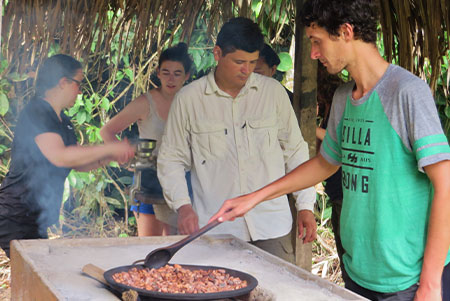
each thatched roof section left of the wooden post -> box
[2,0,294,72]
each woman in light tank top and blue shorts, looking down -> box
[100,43,192,236]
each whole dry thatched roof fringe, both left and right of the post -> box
[2,0,450,93]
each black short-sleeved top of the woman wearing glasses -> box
[0,98,77,229]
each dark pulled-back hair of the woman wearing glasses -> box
[36,54,81,97]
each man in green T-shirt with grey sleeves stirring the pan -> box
[212,0,450,301]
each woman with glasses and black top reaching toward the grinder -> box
[0,54,134,256]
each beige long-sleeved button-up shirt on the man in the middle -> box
[157,71,316,241]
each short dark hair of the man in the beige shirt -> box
[216,17,264,56]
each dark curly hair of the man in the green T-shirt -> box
[300,0,379,43]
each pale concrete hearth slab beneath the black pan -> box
[11,235,364,301]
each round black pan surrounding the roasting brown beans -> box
[103,264,258,300]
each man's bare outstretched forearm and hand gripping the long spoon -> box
[210,154,339,221]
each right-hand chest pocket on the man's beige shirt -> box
[247,117,278,155]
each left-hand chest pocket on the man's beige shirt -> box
[192,121,228,159]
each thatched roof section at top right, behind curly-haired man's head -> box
[380,0,450,95]
